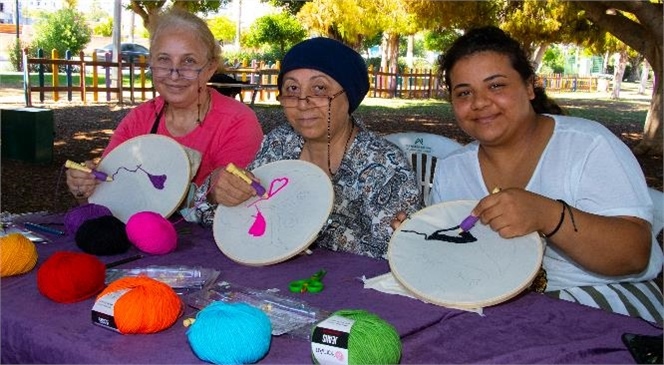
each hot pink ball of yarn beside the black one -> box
[127,211,178,255]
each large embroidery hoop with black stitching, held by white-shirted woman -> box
[387,200,544,309]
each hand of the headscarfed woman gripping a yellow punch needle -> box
[208,168,256,207]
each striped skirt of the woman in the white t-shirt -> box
[544,280,664,325]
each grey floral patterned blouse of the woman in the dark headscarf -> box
[196,121,422,258]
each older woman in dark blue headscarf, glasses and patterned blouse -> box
[199,37,421,258]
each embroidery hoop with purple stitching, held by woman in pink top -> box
[88,134,193,223]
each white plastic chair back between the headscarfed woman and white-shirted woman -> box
[384,132,463,204]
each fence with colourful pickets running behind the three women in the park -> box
[23,50,605,106]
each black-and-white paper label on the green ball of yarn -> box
[311,316,355,365]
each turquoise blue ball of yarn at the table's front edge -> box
[187,301,272,364]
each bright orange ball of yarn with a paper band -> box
[97,276,183,334]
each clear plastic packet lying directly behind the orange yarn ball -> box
[106,265,219,294]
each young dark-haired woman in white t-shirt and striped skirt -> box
[429,27,663,323]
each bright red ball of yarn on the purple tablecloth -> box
[37,251,106,303]
